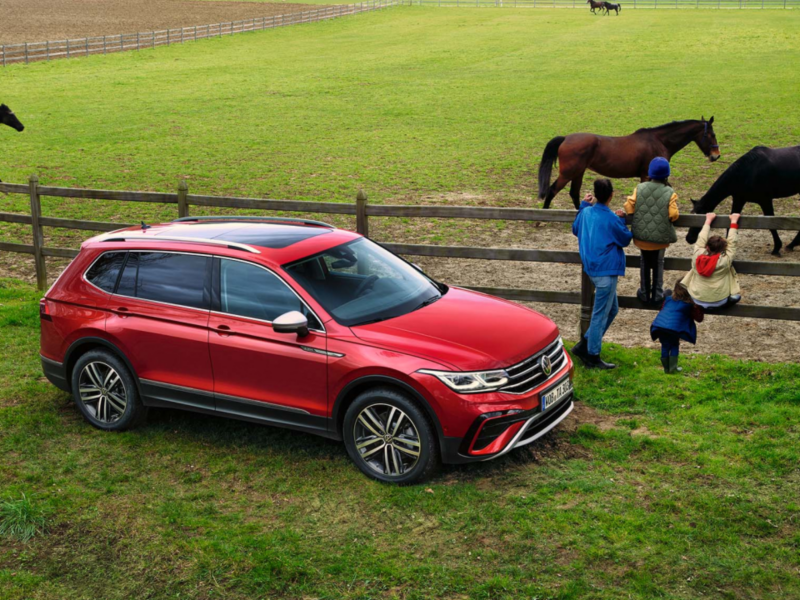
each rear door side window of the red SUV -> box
[135,252,211,308]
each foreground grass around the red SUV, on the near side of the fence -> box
[0,280,800,600]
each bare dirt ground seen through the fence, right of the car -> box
[370,194,800,362]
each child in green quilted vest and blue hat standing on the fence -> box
[625,156,679,304]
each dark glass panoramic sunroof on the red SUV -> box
[155,223,331,249]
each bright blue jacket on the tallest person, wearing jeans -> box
[572,201,633,277]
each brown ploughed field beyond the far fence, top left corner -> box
[0,0,340,44]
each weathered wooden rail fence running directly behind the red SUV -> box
[0,175,800,332]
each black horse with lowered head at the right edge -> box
[686,146,800,256]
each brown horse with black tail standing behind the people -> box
[539,117,719,208]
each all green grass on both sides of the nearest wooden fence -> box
[0,7,800,600]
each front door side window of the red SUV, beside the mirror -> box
[219,259,322,330]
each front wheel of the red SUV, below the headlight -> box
[343,388,440,485]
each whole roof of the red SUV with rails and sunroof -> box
[83,217,361,265]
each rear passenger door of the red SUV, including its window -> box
[106,252,214,410]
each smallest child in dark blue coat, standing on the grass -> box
[650,278,703,374]
